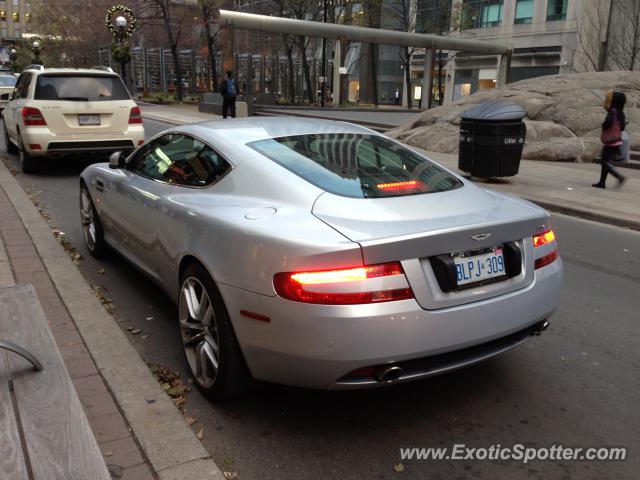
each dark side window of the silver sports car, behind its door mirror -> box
[128,133,231,187]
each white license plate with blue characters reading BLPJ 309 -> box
[453,245,507,287]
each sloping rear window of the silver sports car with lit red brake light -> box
[248,133,462,198]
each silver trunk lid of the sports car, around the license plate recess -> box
[313,183,548,309]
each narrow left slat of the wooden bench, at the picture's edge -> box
[0,350,29,480]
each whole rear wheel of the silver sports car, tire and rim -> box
[178,263,252,400]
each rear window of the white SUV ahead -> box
[35,75,131,102]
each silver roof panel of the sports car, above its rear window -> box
[174,116,378,145]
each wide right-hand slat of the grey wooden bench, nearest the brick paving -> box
[0,285,111,480]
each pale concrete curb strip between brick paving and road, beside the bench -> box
[0,162,224,480]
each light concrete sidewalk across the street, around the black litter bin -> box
[142,106,640,230]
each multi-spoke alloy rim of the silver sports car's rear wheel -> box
[179,277,220,388]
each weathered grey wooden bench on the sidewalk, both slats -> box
[0,285,111,480]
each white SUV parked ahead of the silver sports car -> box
[2,65,144,173]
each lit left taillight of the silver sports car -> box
[273,262,413,305]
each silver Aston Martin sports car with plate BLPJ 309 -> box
[80,117,563,398]
